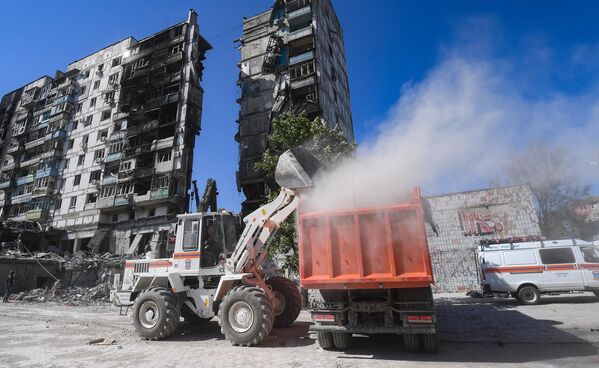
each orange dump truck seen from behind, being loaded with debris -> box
[298,189,438,352]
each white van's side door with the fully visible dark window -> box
[539,248,584,291]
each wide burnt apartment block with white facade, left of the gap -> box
[0,10,211,254]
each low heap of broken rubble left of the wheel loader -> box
[10,280,110,306]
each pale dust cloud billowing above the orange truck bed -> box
[303,54,599,211]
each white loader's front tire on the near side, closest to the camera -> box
[218,285,274,346]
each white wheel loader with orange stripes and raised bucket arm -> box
[113,148,319,346]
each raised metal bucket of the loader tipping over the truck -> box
[275,147,322,189]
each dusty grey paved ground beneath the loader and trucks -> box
[0,294,599,368]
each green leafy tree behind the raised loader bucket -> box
[255,114,356,272]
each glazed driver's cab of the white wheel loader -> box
[174,211,240,273]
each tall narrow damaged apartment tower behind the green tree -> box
[236,0,354,213]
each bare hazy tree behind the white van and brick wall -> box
[496,143,590,238]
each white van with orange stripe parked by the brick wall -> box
[478,239,599,304]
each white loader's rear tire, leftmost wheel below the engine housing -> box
[133,286,180,340]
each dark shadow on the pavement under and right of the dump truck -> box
[332,297,599,363]
